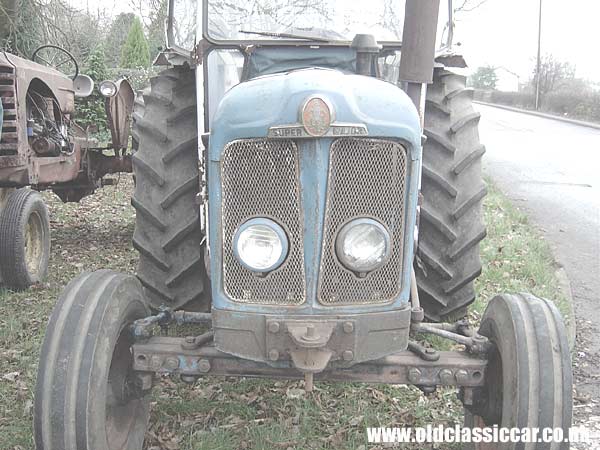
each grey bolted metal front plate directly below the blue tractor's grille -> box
[212,305,411,374]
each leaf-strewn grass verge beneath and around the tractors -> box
[0,177,568,450]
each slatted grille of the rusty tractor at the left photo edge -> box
[0,66,18,156]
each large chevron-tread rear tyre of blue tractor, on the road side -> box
[416,69,487,321]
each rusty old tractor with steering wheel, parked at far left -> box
[0,45,134,289]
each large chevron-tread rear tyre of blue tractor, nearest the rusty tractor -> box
[132,68,208,310]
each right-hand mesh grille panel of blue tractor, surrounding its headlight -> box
[318,138,406,305]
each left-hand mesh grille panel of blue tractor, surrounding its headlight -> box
[221,139,306,305]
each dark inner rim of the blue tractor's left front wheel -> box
[106,327,146,450]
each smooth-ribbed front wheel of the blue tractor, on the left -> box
[34,270,150,450]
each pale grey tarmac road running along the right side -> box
[476,104,600,421]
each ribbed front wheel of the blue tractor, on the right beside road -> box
[465,294,573,450]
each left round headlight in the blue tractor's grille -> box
[233,219,288,273]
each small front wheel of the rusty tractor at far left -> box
[0,189,50,290]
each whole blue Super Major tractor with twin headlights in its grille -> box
[34,0,572,450]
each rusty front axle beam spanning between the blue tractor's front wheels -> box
[132,337,487,387]
